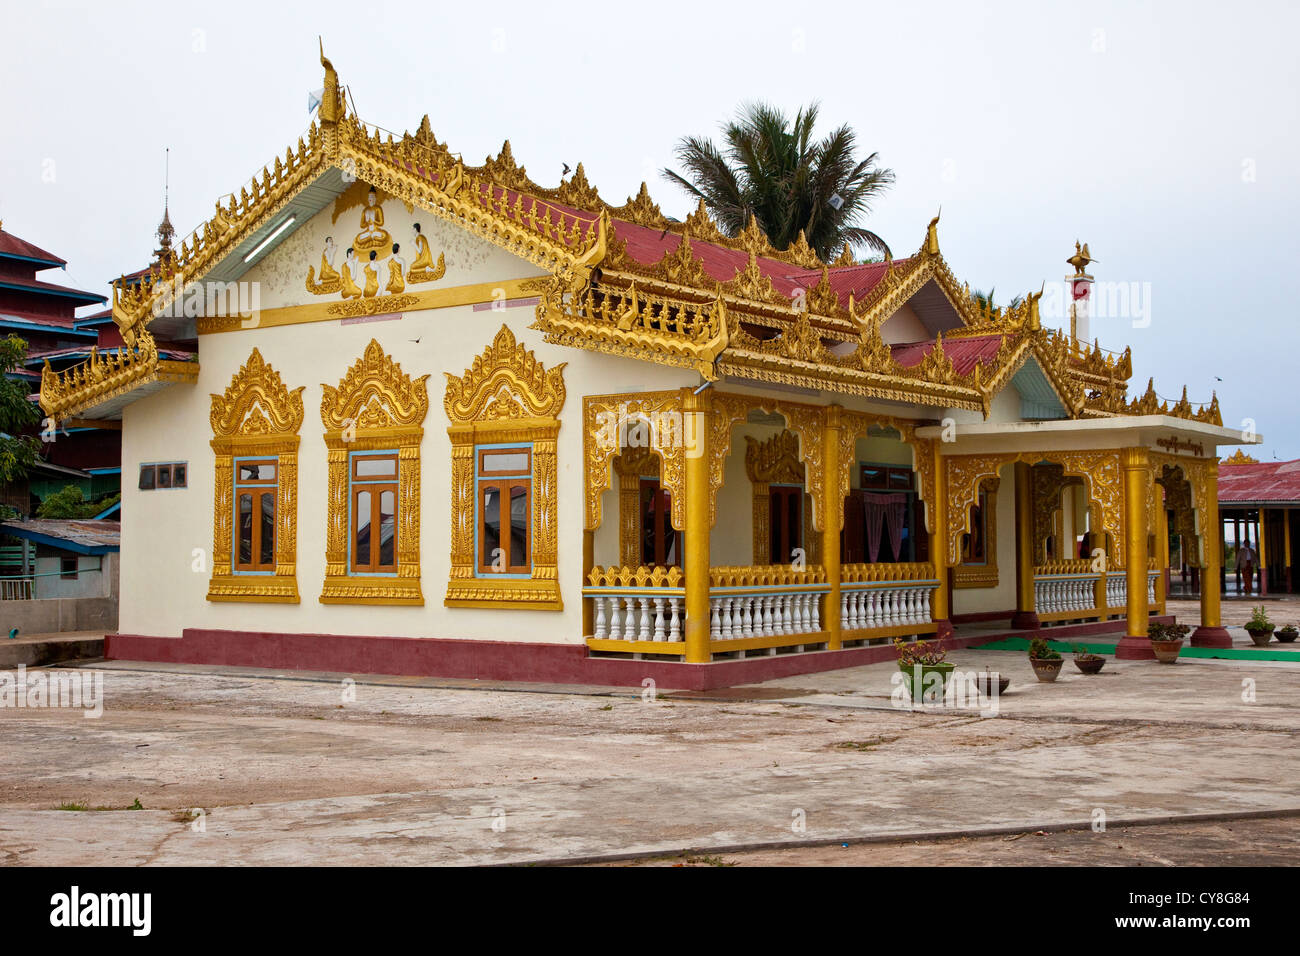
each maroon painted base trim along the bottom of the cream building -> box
[104,628,991,691]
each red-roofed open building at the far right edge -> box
[1218,451,1300,594]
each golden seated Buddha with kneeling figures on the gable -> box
[307,182,447,299]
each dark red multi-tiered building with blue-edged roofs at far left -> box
[0,224,121,515]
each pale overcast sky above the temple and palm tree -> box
[0,1,1300,460]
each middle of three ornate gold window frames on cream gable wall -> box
[320,338,429,605]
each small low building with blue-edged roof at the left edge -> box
[0,518,121,633]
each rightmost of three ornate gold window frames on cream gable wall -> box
[443,325,567,611]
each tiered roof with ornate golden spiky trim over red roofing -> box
[42,51,1218,429]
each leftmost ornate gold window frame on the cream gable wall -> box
[207,349,303,604]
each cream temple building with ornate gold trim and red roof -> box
[42,52,1258,687]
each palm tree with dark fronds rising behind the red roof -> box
[663,103,894,260]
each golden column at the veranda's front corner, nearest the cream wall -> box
[681,389,712,663]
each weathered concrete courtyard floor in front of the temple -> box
[0,634,1300,865]
